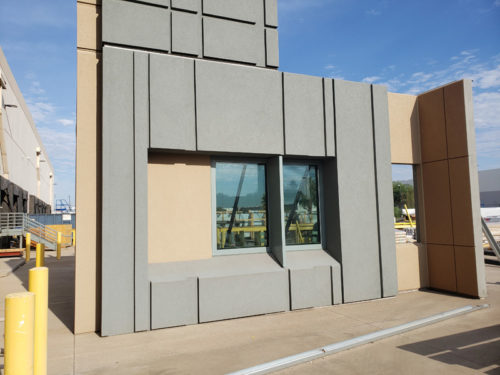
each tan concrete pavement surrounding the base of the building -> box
[0,249,500,375]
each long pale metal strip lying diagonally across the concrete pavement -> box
[228,305,489,375]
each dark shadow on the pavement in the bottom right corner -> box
[399,325,500,375]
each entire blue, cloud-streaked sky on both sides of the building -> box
[0,0,500,201]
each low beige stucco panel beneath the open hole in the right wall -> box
[396,243,429,291]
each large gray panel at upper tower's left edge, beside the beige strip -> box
[102,0,170,51]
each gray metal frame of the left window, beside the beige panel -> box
[210,156,271,256]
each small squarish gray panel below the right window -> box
[290,266,332,310]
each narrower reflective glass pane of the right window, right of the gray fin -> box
[283,165,320,245]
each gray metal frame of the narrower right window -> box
[282,159,326,251]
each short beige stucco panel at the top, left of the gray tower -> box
[76,2,101,50]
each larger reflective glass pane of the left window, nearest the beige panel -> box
[215,162,267,249]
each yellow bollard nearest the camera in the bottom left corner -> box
[4,292,35,375]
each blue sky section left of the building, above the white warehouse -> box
[0,0,76,203]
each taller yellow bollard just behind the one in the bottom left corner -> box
[29,267,49,375]
